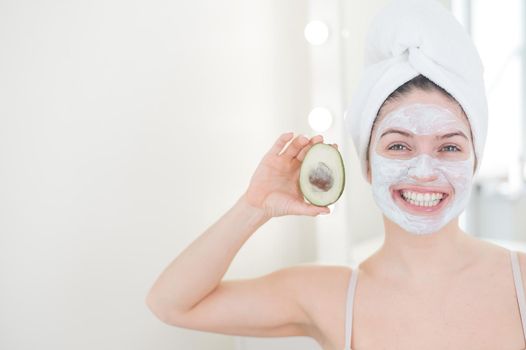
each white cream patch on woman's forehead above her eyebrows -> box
[375,103,469,141]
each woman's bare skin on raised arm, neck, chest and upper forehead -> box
[146,90,526,350]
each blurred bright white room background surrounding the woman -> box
[0,0,526,350]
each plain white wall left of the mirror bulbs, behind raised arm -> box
[0,0,315,350]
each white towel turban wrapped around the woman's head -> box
[344,0,488,177]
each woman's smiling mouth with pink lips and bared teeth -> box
[391,186,451,215]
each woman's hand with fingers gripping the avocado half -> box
[243,132,337,219]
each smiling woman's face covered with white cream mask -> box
[368,90,474,234]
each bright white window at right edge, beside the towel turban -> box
[452,0,526,177]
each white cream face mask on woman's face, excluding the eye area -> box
[371,104,474,234]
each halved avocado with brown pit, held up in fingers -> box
[299,143,345,207]
